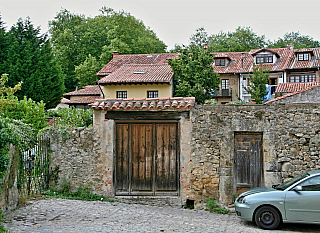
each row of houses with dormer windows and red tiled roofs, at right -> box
[213,47,320,104]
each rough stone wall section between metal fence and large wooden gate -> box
[49,128,111,196]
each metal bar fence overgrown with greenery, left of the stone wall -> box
[18,135,50,195]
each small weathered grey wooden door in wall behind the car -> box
[234,133,263,194]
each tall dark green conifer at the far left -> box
[4,18,64,108]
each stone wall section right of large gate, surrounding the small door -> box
[189,104,320,205]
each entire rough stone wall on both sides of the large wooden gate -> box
[51,104,320,208]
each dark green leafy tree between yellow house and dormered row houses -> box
[168,44,220,103]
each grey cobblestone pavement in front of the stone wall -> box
[4,199,320,233]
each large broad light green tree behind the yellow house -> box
[49,7,166,91]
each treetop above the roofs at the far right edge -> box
[269,32,320,49]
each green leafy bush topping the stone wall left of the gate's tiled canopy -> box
[48,108,93,127]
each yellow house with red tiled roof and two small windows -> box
[97,52,177,99]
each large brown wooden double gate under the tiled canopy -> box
[114,123,179,196]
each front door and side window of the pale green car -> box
[285,176,320,222]
